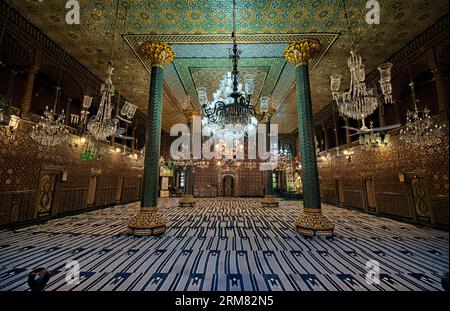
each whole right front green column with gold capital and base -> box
[284,39,334,237]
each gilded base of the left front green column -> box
[128,208,167,236]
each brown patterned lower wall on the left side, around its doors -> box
[0,122,142,225]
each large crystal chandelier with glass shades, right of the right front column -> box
[330,2,392,128]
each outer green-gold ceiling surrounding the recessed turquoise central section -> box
[7,0,448,130]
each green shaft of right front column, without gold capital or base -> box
[295,63,320,209]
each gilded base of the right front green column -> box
[295,208,334,237]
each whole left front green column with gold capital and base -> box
[128,41,175,236]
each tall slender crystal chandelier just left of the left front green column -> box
[87,62,119,141]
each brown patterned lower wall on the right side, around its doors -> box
[318,133,449,226]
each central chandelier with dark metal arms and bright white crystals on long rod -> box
[197,1,269,140]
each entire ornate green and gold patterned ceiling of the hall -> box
[8,0,448,132]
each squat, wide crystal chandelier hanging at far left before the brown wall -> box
[30,87,69,147]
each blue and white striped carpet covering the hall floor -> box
[0,198,449,291]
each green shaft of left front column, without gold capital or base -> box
[141,66,164,207]
